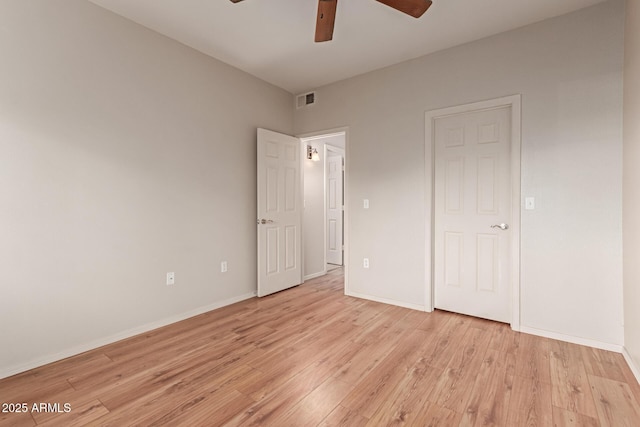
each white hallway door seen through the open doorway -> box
[326,150,343,265]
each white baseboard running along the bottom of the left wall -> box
[0,292,256,379]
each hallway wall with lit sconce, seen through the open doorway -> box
[302,134,345,278]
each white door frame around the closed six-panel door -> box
[424,95,522,331]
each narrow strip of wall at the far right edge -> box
[623,1,640,381]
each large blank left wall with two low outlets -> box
[0,0,293,377]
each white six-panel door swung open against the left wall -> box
[257,129,302,297]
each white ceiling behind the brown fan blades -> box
[90,0,605,94]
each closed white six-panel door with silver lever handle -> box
[433,107,511,323]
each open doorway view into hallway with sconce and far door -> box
[300,129,348,288]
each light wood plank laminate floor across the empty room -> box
[0,269,640,427]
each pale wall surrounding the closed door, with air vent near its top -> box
[295,0,624,347]
